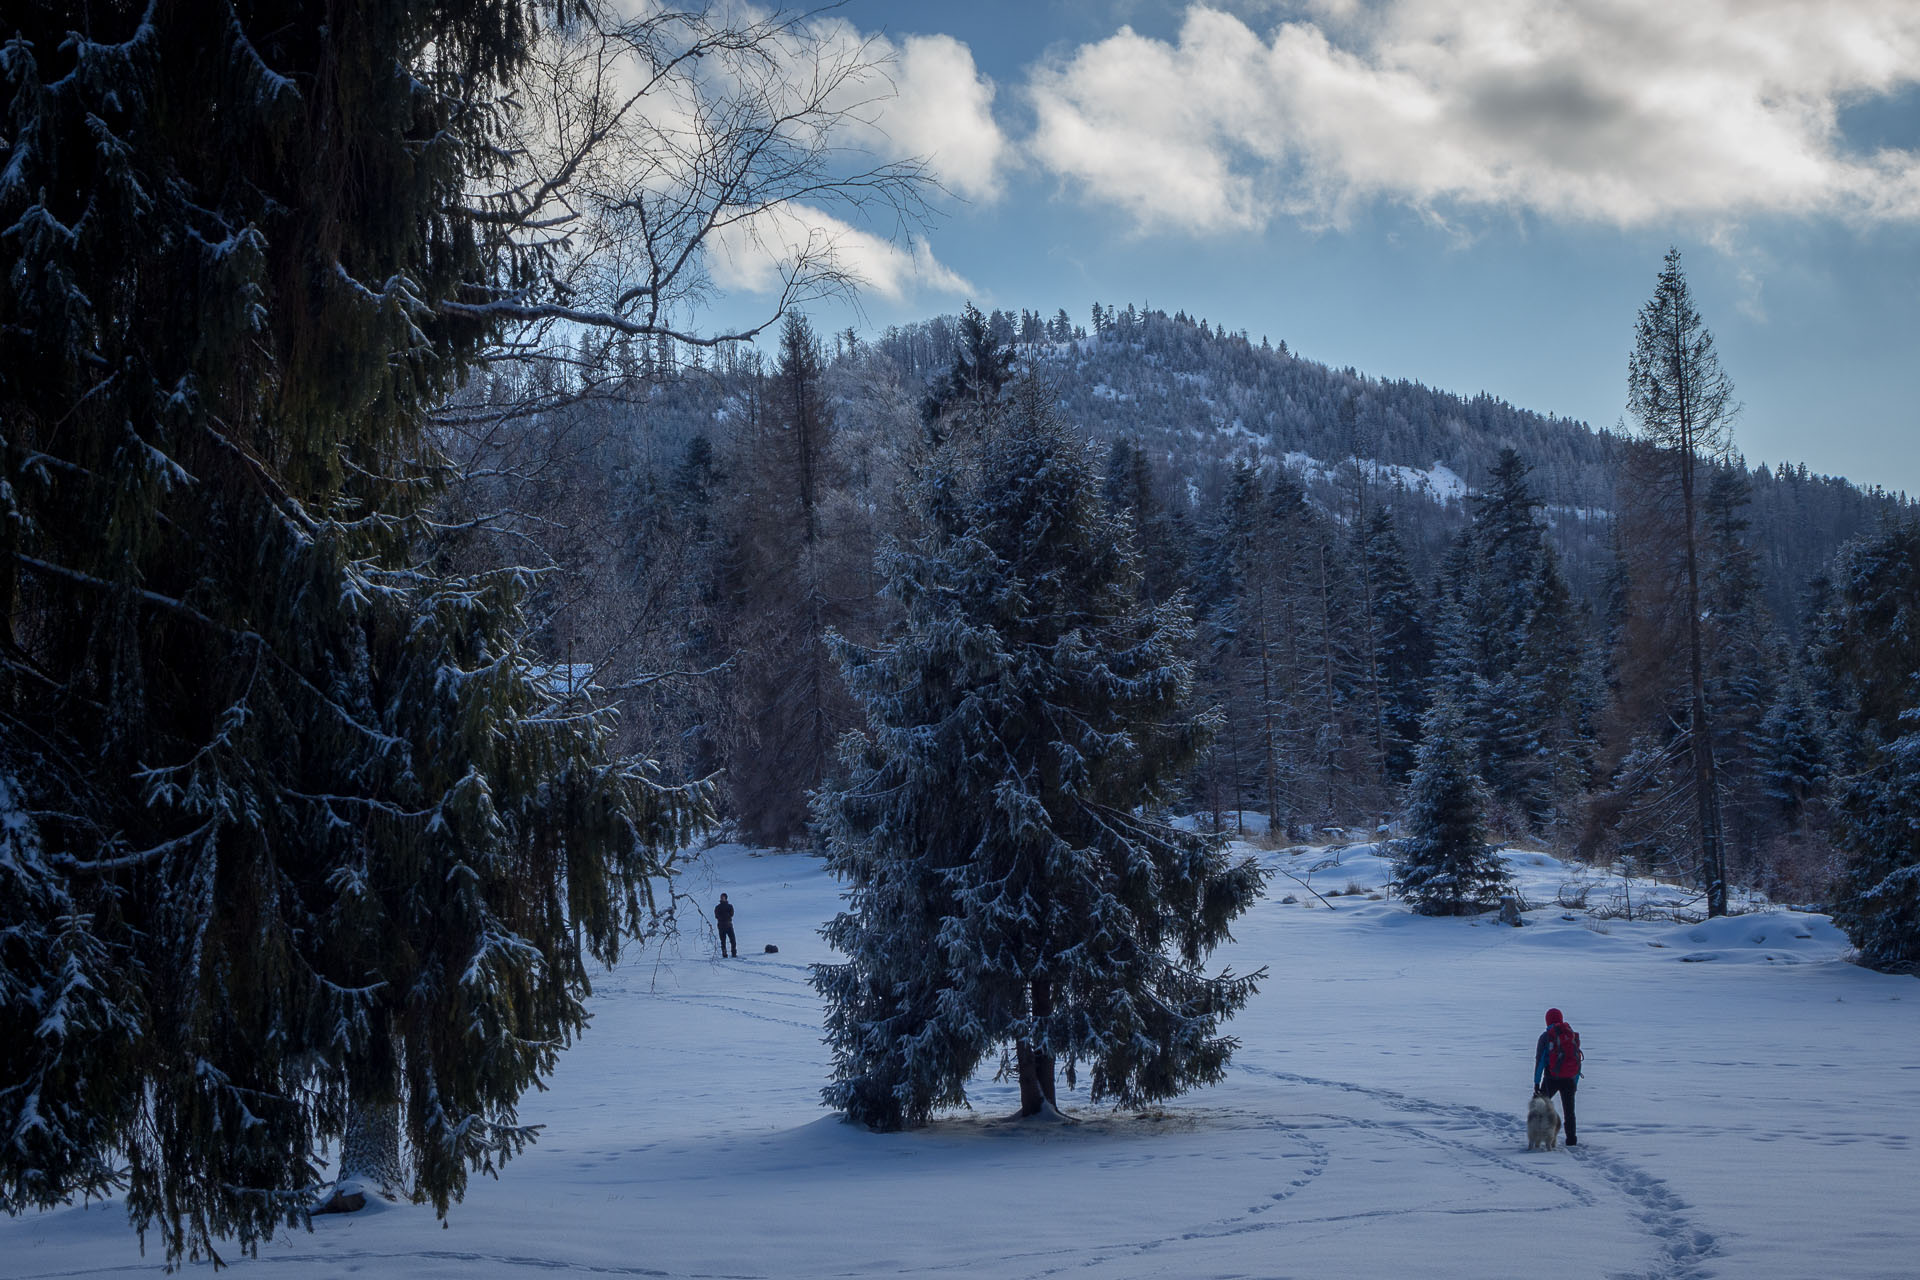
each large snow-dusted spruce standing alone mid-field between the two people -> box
[814,380,1261,1128]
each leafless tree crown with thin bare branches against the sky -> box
[442,0,931,376]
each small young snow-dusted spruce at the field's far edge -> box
[1394,695,1511,915]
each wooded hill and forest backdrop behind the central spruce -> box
[428,305,1908,932]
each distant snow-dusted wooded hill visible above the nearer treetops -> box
[533,305,1907,637]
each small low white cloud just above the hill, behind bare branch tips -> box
[707,203,975,301]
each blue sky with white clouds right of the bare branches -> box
[714,0,1920,493]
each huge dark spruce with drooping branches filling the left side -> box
[0,0,701,1261]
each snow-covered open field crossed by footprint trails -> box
[0,846,1920,1280]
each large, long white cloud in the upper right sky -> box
[1027,0,1920,232]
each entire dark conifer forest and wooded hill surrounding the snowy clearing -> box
[0,0,1920,1259]
